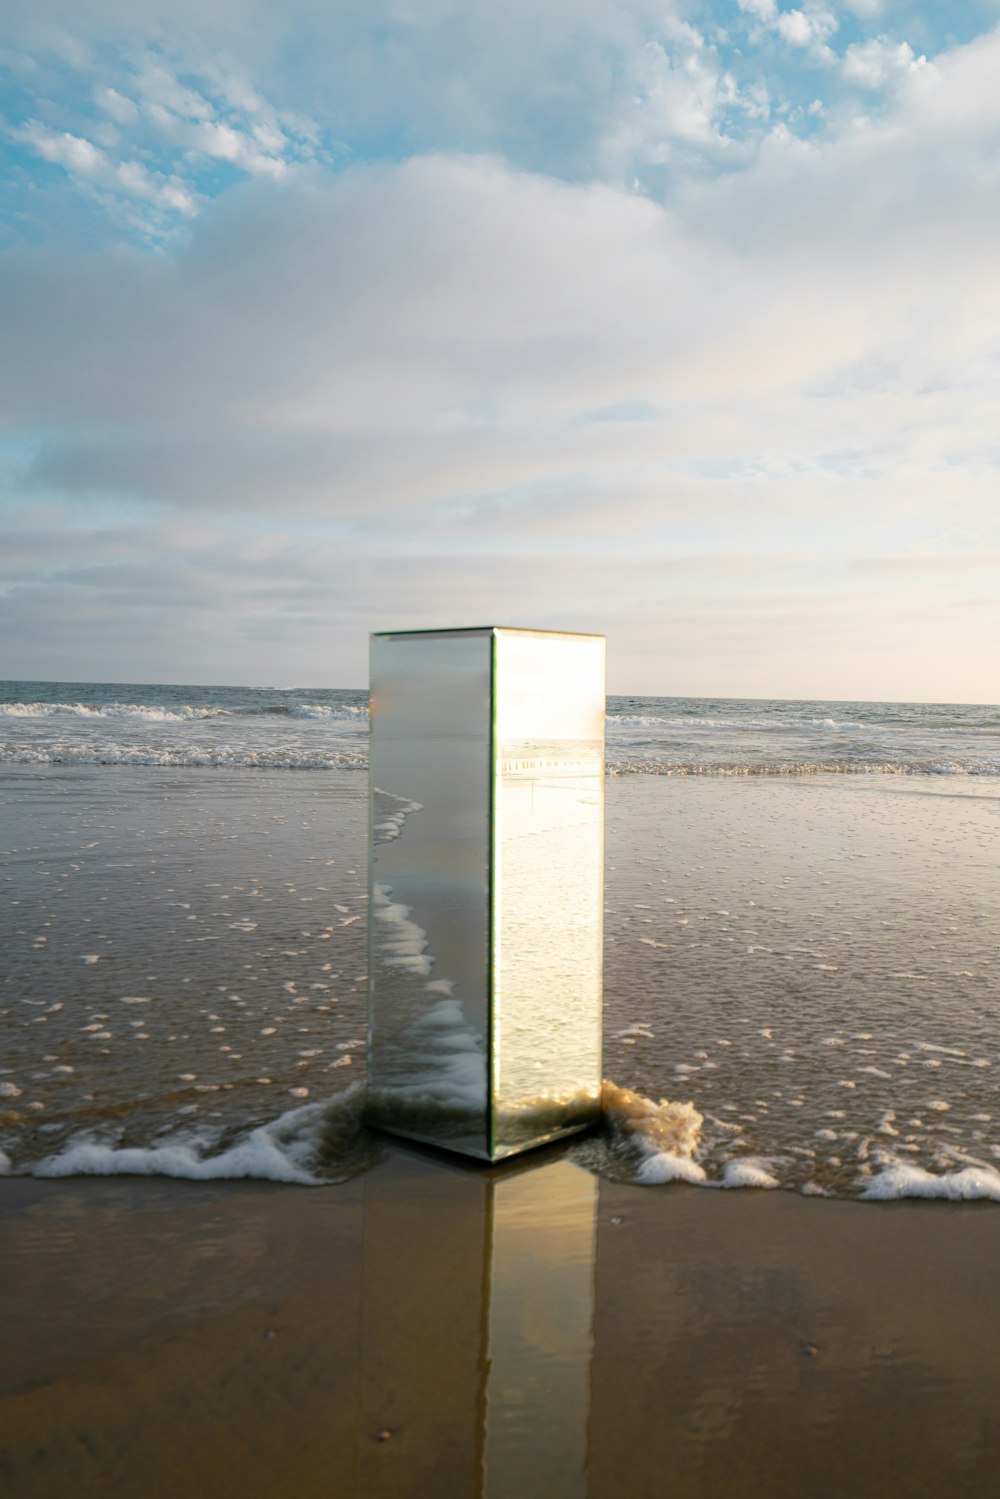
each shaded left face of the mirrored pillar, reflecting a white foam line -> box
[369,630,492,1156]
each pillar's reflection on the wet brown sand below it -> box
[358,1153,598,1499]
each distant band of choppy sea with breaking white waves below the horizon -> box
[0,682,1000,776]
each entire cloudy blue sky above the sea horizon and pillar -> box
[0,0,1000,702]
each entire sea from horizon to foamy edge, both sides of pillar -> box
[0,682,1000,1201]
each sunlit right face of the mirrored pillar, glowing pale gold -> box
[492,630,604,1156]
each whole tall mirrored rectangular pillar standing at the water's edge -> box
[367,628,604,1160]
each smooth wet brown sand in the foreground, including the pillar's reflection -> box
[0,1145,1000,1499]
